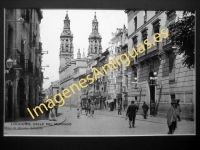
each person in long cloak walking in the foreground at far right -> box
[167,100,177,134]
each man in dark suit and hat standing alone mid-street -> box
[126,101,138,128]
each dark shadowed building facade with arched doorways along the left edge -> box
[5,9,43,120]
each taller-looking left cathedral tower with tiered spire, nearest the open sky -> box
[59,12,74,71]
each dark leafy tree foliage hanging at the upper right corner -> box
[169,11,195,68]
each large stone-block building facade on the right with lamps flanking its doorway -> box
[126,10,195,117]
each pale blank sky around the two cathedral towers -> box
[40,9,128,89]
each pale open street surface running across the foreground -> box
[4,107,194,136]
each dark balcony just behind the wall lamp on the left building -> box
[6,48,24,69]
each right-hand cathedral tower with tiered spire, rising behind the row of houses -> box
[88,12,102,56]
